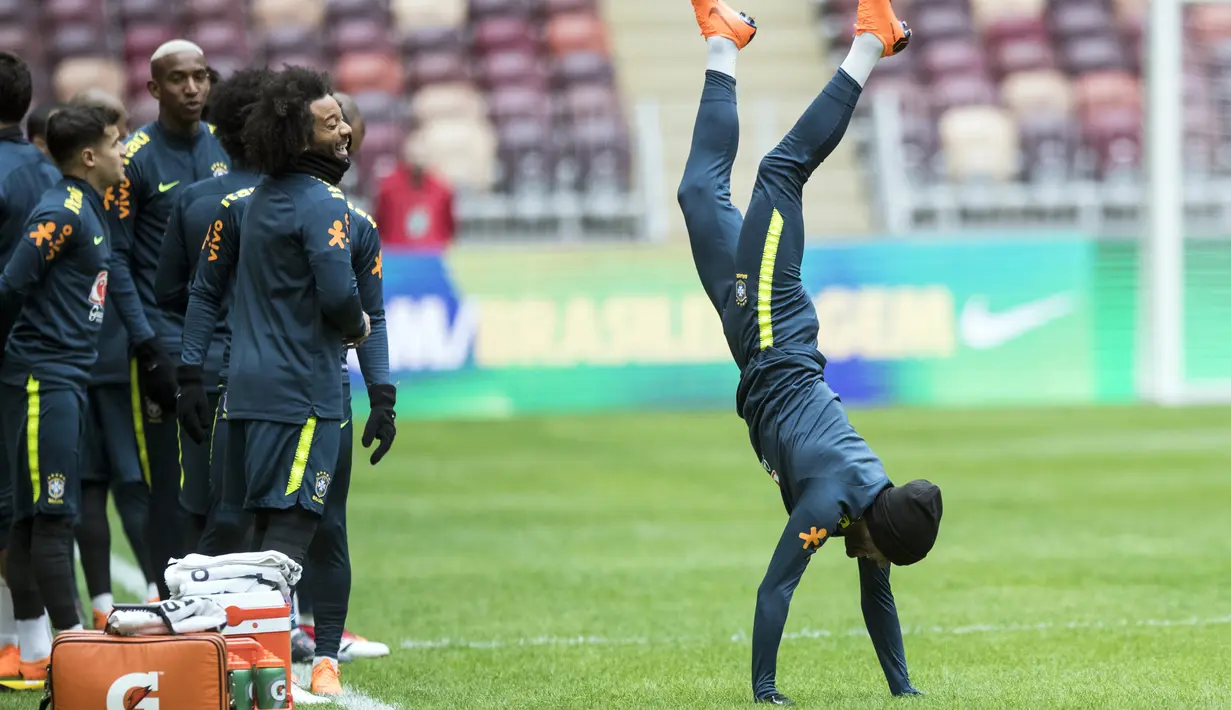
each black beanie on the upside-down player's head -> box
[864,480,944,566]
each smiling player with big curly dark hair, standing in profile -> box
[225,66,371,564]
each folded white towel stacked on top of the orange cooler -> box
[164,552,303,598]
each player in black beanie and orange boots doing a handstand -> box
[680,0,942,705]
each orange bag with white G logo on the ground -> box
[41,631,230,710]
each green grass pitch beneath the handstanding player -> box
[0,409,1231,710]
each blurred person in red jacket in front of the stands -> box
[375,135,454,251]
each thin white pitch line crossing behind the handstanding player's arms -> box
[401,615,1231,650]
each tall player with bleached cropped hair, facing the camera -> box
[118,39,230,599]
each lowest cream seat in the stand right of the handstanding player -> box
[939,106,1019,182]
